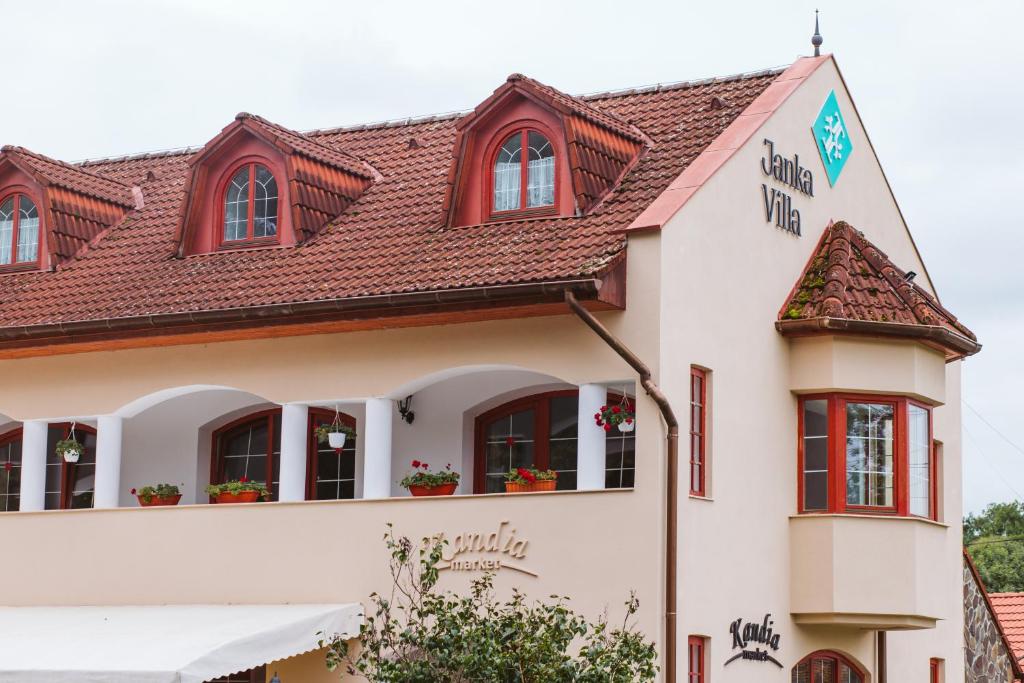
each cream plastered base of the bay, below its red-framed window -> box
[790,514,949,631]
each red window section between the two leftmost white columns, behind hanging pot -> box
[45,423,96,510]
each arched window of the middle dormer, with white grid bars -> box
[221,162,279,243]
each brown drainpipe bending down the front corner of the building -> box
[565,290,679,683]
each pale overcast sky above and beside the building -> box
[0,0,1024,511]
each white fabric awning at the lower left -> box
[0,603,362,683]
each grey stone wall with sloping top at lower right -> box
[966,558,1014,683]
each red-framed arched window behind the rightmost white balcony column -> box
[473,389,636,494]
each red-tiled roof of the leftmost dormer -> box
[0,145,135,263]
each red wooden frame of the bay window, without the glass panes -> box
[797,392,938,520]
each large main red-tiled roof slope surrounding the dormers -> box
[0,66,779,339]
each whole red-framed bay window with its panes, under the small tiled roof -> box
[798,394,937,519]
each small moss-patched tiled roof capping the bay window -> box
[776,221,981,355]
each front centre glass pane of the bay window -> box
[846,402,895,507]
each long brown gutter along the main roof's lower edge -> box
[0,278,603,346]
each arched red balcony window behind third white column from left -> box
[210,408,356,501]
